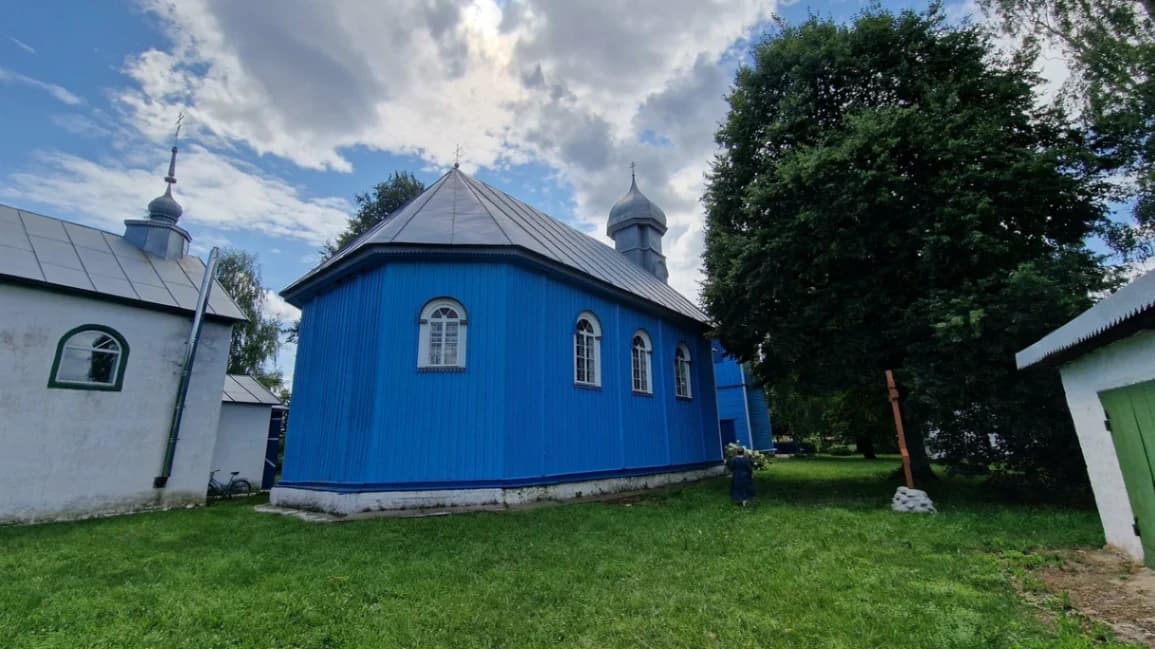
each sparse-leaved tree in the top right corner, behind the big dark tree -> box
[981,0,1155,255]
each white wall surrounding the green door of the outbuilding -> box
[1059,331,1155,560]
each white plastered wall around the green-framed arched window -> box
[0,283,231,522]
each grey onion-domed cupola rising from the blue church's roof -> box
[605,165,670,282]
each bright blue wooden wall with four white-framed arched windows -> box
[281,261,721,491]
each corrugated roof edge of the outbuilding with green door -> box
[1014,270,1155,370]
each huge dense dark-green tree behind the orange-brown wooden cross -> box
[703,7,1108,479]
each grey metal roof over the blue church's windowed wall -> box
[283,169,709,322]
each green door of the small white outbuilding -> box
[1098,381,1155,568]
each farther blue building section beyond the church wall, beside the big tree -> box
[713,343,774,452]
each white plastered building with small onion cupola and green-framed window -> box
[0,148,244,522]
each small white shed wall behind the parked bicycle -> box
[213,402,273,490]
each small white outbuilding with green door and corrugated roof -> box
[1015,271,1155,567]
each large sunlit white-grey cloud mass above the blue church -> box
[110,0,774,298]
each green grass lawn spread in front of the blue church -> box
[0,458,1136,649]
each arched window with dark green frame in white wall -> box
[49,325,128,390]
